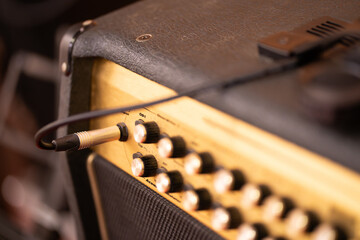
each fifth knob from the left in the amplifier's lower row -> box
[236,223,268,240]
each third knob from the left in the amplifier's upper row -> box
[184,152,215,175]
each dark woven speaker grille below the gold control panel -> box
[93,156,222,240]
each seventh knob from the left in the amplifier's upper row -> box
[286,208,318,237]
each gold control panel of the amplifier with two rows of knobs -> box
[87,59,360,240]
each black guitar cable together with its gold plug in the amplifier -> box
[35,31,359,151]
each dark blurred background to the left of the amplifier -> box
[0,0,134,240]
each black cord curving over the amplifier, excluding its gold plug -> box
[35,30,359,150]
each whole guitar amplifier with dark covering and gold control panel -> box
[54,0,360,240]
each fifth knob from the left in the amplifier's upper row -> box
[241,183,270,208]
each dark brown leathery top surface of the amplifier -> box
[68,0,360,171]
